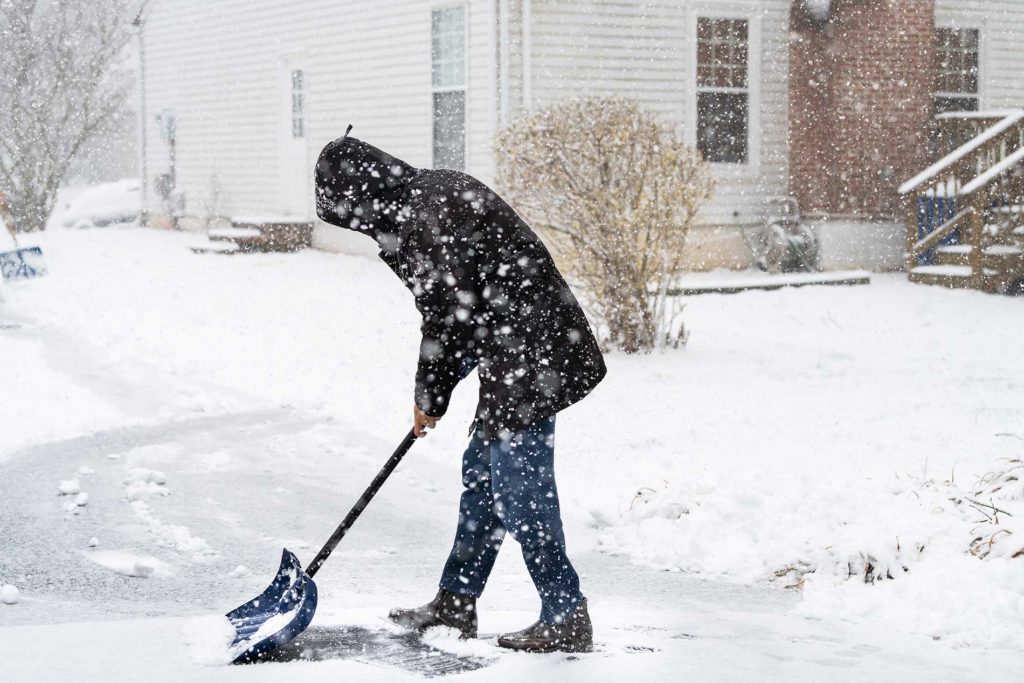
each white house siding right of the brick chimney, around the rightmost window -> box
[935,0,1024,110]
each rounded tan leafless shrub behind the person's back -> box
[496,97,714,353]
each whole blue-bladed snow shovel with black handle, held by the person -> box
[226,431,416,664]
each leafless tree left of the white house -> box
[0,0,145,231]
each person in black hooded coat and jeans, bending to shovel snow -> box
[315,134,605,651]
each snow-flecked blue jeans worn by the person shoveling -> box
[440,416,583,624]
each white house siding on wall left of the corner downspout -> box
[144,0,497,235]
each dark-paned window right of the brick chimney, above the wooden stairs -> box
[935,29,978,114]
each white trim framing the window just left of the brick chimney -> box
[683,0,762,178]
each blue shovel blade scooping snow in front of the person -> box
[226,548,316,664]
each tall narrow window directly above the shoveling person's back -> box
[430,7,466,170]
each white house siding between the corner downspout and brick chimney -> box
[524,0,790,242]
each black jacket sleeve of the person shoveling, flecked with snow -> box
[406,189,478,417]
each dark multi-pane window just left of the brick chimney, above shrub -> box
[696,16,750,164]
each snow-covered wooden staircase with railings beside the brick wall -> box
[899,110,1024,294]
